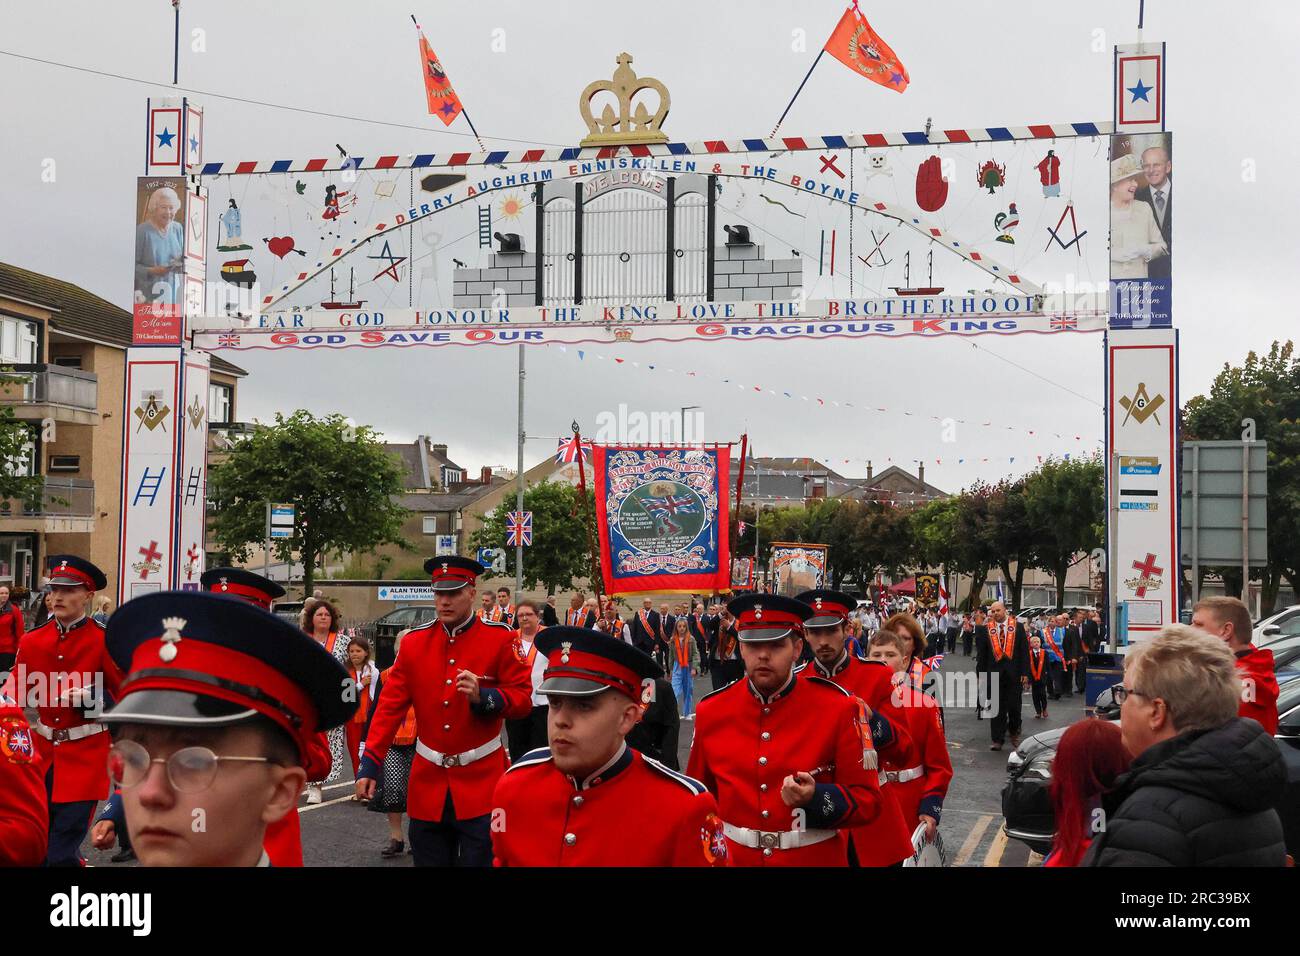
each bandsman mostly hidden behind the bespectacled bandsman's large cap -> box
[91,567,327,866]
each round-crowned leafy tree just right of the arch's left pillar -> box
[208,408,410,594]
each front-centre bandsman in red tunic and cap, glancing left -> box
[491,627,727,866]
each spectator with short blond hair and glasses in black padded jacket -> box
[1083,624,1287,866]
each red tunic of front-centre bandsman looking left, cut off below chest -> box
[488,743,727,866]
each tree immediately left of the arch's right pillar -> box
[1017,455,1106,607]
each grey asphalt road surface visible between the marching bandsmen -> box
[86,653,1084,866]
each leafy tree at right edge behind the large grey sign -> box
[1182,342,1300,613]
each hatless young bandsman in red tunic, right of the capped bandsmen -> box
[868,631,953,843]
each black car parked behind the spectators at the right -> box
[1002,681,1300,856]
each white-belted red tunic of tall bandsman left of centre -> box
[360,614,533,821]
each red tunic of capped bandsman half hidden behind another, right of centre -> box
[800,650,915,866]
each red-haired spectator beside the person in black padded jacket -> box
[1035,717,1131,866]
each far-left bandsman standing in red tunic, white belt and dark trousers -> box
[13,554,122,866]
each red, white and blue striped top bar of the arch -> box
[198,122,1114,176]
